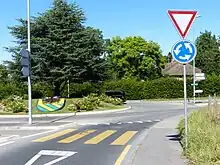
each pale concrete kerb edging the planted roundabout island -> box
[0,106,131,118]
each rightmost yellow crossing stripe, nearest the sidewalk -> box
[111,131,137,145]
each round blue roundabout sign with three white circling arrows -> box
[171,40,197,64]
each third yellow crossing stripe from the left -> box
[84,130,117,144]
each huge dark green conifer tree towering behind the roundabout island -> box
[5,0,105,95]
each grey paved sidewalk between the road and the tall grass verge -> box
[132,115,187,165]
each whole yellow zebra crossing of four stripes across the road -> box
[32,129,138,146]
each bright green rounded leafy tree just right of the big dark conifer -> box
[105,36,164,80]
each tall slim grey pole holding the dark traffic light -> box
[27,0,32,124]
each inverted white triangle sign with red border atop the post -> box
[168,10,197,39]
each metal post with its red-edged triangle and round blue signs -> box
[168,10,197,149]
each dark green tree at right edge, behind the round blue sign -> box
[196,31,220,75]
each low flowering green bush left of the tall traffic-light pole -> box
[1,95,27,113]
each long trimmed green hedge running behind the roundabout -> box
[0,75,220,100]
